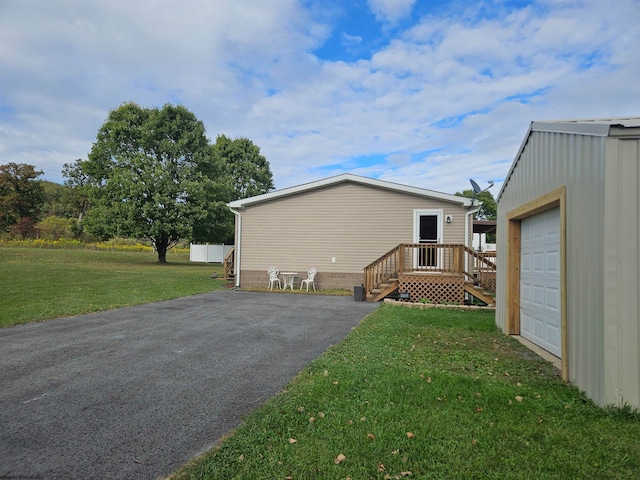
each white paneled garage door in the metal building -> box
[520,208,561,357]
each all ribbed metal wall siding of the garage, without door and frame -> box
[496,122,640,406]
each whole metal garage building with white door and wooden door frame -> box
[496,117,640,408]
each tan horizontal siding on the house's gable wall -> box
[240,182,466,288]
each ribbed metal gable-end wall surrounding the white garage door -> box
[496,131,605,403]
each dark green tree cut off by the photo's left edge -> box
[0,163,44,232]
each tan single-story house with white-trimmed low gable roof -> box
[229,174,496,300]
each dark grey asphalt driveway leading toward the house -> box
[0,290,377,480]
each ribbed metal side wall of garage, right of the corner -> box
[604,138,640,408]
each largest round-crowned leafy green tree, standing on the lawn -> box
[75,103,218,263]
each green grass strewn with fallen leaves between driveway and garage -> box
[171,305,640,480]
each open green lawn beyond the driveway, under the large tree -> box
[0,248,228,327]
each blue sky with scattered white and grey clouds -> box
[0,0,640,194]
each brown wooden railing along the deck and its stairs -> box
[364,243,496,295]
